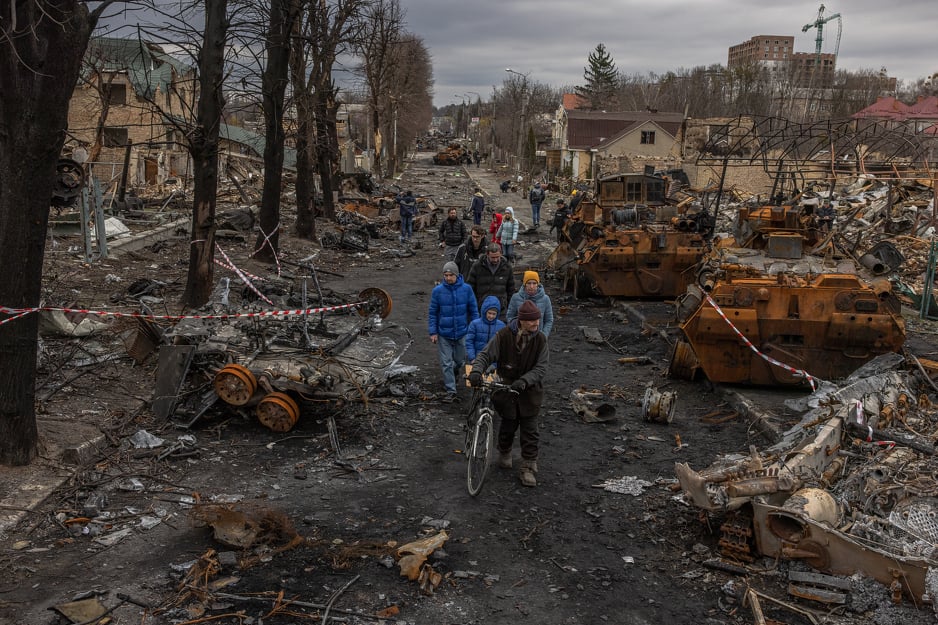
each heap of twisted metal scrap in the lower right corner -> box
[675,354,938,604]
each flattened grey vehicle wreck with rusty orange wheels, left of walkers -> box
[146,266,402,432]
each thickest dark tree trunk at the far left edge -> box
[0,0,95,465]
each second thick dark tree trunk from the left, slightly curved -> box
[182,0,228,307]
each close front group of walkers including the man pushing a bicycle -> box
[427,215,554,486]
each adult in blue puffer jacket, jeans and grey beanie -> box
[427,261,479,403]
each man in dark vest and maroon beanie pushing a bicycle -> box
[469,300,548,486]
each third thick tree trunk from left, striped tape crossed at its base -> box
[254,0,298,262]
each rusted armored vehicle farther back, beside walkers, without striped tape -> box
[548,173,712,298]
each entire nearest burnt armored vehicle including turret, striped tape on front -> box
[669,206,905,386]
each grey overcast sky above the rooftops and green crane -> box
[401,0,938,106]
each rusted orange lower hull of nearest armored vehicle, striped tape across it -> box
[670,256,905,386]
